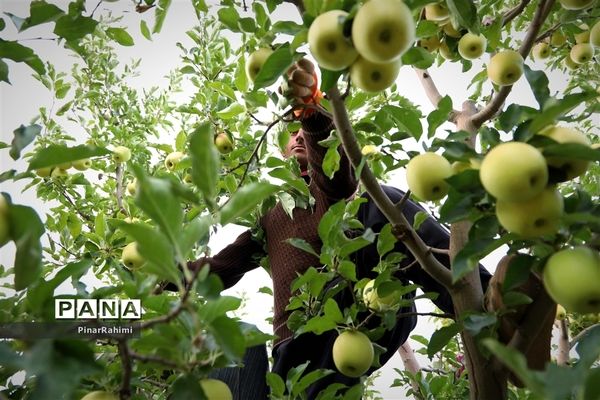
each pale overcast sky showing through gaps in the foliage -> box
[0,0,580,400]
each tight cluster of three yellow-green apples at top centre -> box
[308,0,415,92]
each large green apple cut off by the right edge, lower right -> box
[543,246,600,314]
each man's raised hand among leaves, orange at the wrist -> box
[279,58,323,119]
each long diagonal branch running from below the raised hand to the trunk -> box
[327,87,452,287]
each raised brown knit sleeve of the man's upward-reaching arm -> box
[302,113,358,200]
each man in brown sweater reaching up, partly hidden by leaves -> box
[189,60,547,399]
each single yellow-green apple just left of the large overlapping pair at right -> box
[406,152,452,201]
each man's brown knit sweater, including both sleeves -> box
[190,113,357,344]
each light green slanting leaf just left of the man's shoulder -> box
[221,182,279,226]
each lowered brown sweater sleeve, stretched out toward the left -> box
[188,230,265,289]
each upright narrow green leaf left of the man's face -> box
[189,122,220,207]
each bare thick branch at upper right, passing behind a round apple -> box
[471,0,555,128]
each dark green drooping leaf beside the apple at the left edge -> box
[8,204,45,291]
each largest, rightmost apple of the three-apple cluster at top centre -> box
[352,0,415,63]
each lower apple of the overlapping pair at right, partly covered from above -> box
[496,187,564,238]
